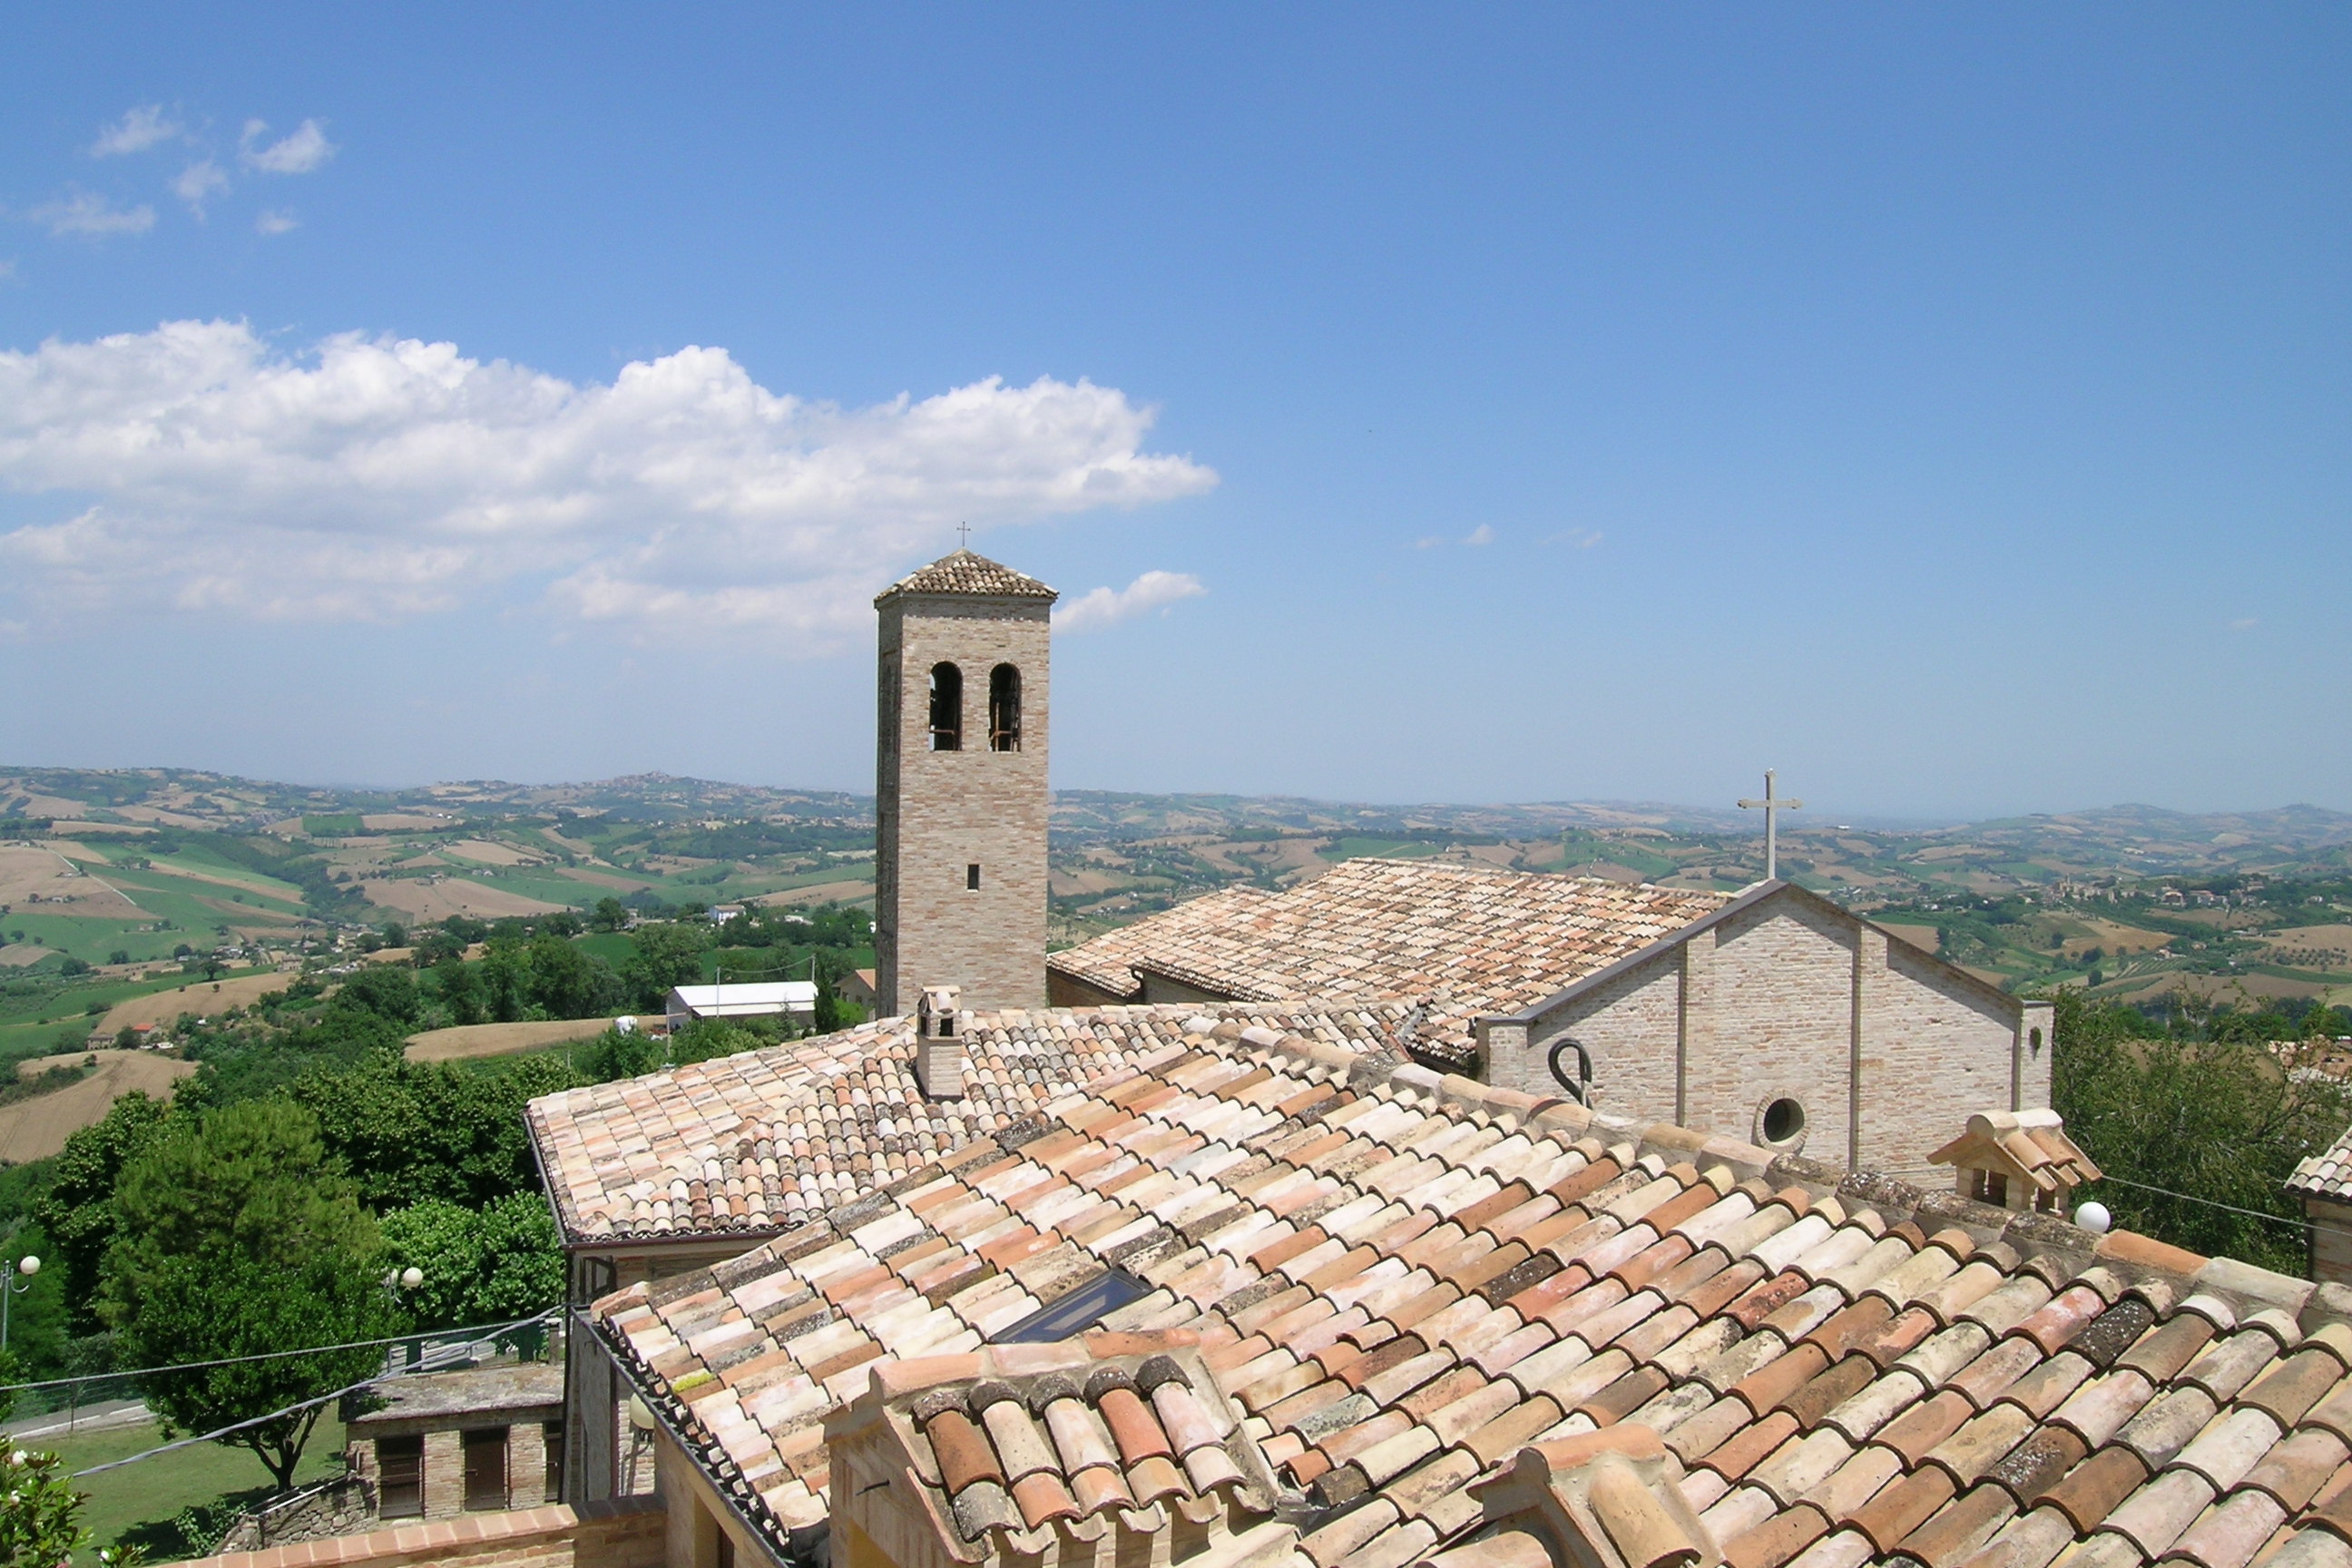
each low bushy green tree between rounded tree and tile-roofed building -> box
[383,1191,564,1328]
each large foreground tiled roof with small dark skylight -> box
[597,1018,2352,1568]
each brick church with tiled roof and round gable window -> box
[1046,860,2051,1175]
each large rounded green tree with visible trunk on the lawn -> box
[101,1098,400,1485]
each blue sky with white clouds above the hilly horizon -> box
[0,5,2352,818]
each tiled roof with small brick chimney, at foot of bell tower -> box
[524,1004,1406,1243]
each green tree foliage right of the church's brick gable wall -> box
[2051,990,2352,1274]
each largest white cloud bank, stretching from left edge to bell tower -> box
[0,322,1216,644]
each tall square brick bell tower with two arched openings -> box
[875,550,1058,1015]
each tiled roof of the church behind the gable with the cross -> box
[1046,860,1731,1060]
